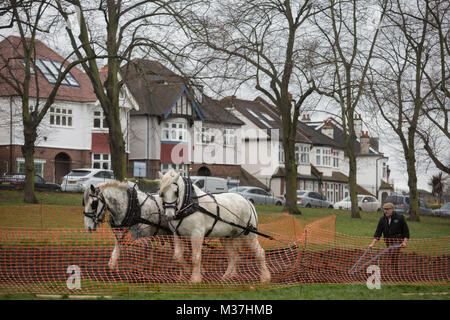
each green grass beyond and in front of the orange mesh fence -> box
[0,190,450,300]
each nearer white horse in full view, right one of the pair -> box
[159,169,271,283]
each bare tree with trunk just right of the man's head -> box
[369,1,437,221]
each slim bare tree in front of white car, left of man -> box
[314,0,388,218]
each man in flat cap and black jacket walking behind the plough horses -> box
[369,202,409,272]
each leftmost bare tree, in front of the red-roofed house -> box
[0,0,83,203]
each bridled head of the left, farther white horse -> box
[83,185,106,231]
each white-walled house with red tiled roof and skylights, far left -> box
[0,36,136,183]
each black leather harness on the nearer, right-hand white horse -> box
[163,177,275,240]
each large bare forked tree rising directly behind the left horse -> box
[56,0,199,180]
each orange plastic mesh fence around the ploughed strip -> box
[0,206,450,295]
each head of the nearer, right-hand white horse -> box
[159,169,183,220]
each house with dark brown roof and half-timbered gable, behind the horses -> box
[121,59,250,179]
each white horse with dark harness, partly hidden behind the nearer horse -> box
[83,180,172,270]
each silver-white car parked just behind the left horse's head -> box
[61,168,137,192]
